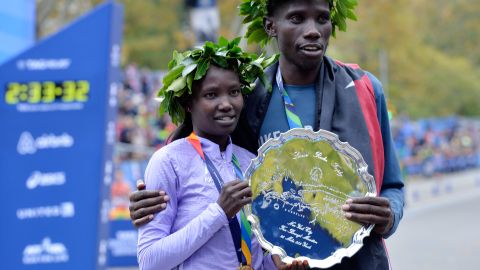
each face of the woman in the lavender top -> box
[189,65,243,146]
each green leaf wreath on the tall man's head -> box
[239,0,358,47]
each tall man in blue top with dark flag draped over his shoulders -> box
[130,0,404,270]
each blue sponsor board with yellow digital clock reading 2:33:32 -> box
[0,1,123,270]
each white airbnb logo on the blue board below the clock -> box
[17,131,74,155]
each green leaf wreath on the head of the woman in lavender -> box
[157,37,278,124]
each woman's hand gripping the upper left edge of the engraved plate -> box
[217,180,252,219]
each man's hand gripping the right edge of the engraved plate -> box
[342,197,393,235]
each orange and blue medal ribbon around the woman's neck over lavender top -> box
[187,132,252,266]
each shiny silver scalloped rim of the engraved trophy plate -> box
[245,128,377,269]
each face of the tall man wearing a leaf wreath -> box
[265,0,332,70]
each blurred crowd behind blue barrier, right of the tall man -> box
[392,117,480,176]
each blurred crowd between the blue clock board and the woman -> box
[109,64,175,220]
